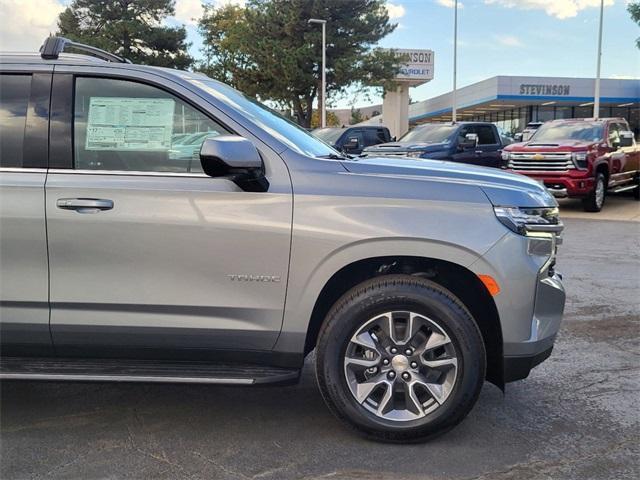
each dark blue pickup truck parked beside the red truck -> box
[363,122,503,168]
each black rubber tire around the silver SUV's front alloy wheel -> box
[316,275,486,443]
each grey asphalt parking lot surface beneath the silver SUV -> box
[0,198,640,480]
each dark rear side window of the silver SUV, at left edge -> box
[0,75,31,168]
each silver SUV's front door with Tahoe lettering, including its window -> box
[46,72,292,356]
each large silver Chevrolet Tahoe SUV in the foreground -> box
[0,38,565,442]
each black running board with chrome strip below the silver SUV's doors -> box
[0,357,300,385]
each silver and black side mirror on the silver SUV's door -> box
[200,135,269,192]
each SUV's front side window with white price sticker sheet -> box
[73,77,229,173]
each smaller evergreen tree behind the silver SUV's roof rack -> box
[57,0,193,69]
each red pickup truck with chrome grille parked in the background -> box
[502,118,640,212]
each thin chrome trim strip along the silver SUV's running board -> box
[0,373,255,385]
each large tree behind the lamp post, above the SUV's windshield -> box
[199,0,398,127]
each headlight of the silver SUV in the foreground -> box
[493,207,564,236]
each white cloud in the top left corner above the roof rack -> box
[0,0,64,52]
